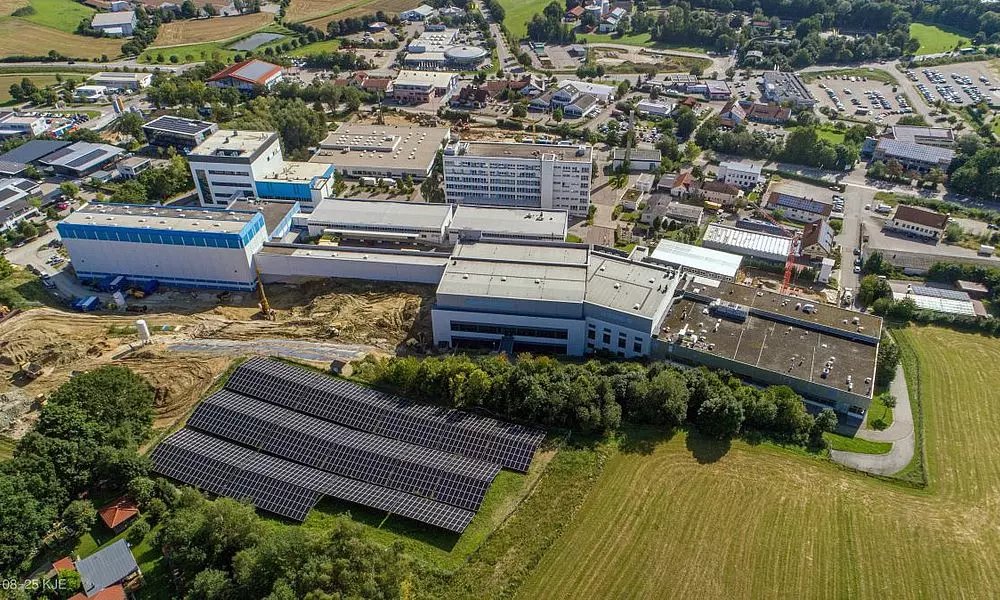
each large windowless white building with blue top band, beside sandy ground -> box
[56,203,267,290]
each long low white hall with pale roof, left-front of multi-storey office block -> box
[306,199,452,245]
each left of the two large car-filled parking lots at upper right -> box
[808,75,914,125]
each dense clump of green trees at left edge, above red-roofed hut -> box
[0,366,154,574]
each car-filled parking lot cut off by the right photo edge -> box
[906,62,1000,105]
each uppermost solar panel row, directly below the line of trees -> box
[226,359,544,472]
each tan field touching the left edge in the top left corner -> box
[0,17,122,60]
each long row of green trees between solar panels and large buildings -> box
[356,355,837,445]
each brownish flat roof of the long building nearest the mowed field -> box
[661,291,877,396]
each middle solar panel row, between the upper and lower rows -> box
[188,390,500,510]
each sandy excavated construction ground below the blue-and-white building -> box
[0,281,433,439]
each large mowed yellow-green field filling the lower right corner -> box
[520,327,1000,600]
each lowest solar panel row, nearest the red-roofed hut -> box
[152,429,475,533]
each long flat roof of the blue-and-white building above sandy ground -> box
[60,202,257,233]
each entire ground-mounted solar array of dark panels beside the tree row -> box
[152,359,544,533]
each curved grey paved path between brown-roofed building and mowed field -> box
[830,366,916,475]
